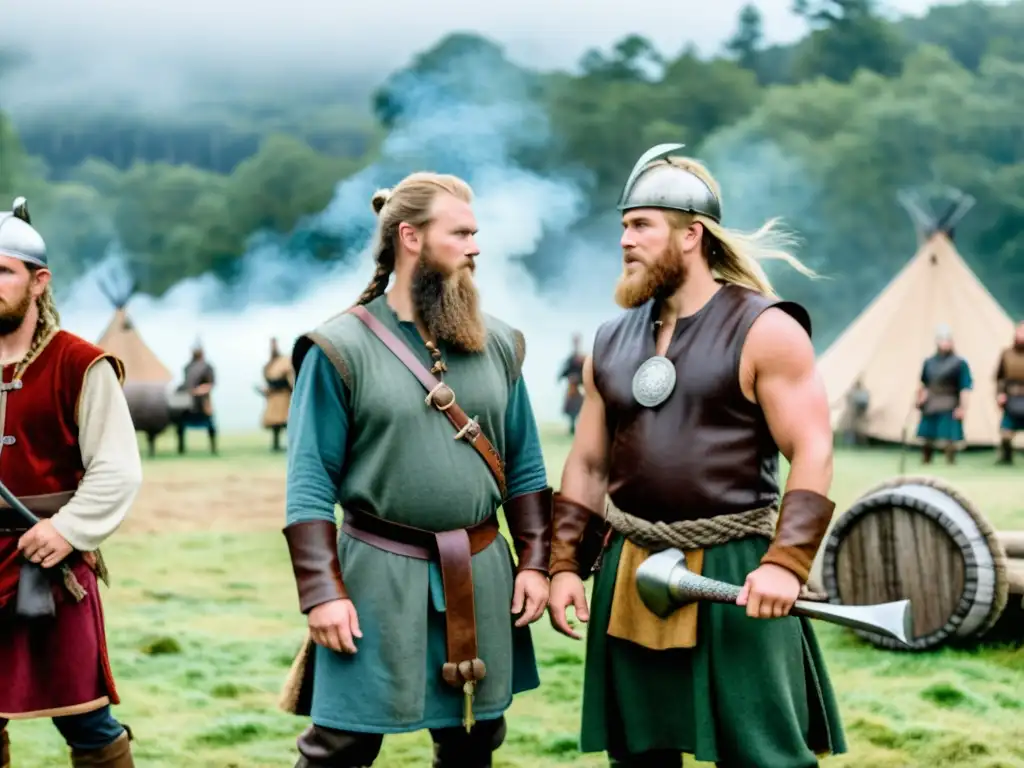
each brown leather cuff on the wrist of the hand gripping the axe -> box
[761,490,836,584]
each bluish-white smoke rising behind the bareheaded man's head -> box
[60,48,629,431]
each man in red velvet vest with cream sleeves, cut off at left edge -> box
[0,198,142,768]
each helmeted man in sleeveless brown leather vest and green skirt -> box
[549,144,846,768]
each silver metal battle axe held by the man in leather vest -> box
[636,549,911,646]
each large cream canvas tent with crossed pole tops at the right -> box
[818,190,1021,446]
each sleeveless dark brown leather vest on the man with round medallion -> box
[593,285,810,522]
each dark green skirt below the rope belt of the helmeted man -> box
[581,536,846,768]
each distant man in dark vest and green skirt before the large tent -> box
[918,326,973,464]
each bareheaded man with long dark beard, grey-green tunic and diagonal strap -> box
[282,173,551,768]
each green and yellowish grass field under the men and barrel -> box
[9,432,1024,768]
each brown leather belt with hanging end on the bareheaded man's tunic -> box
[341,507,498,687]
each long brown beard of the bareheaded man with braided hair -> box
[412,248,487,352]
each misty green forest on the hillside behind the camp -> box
[0,0,1024,345]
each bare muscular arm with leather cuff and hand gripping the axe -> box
[741,309,836,617]
